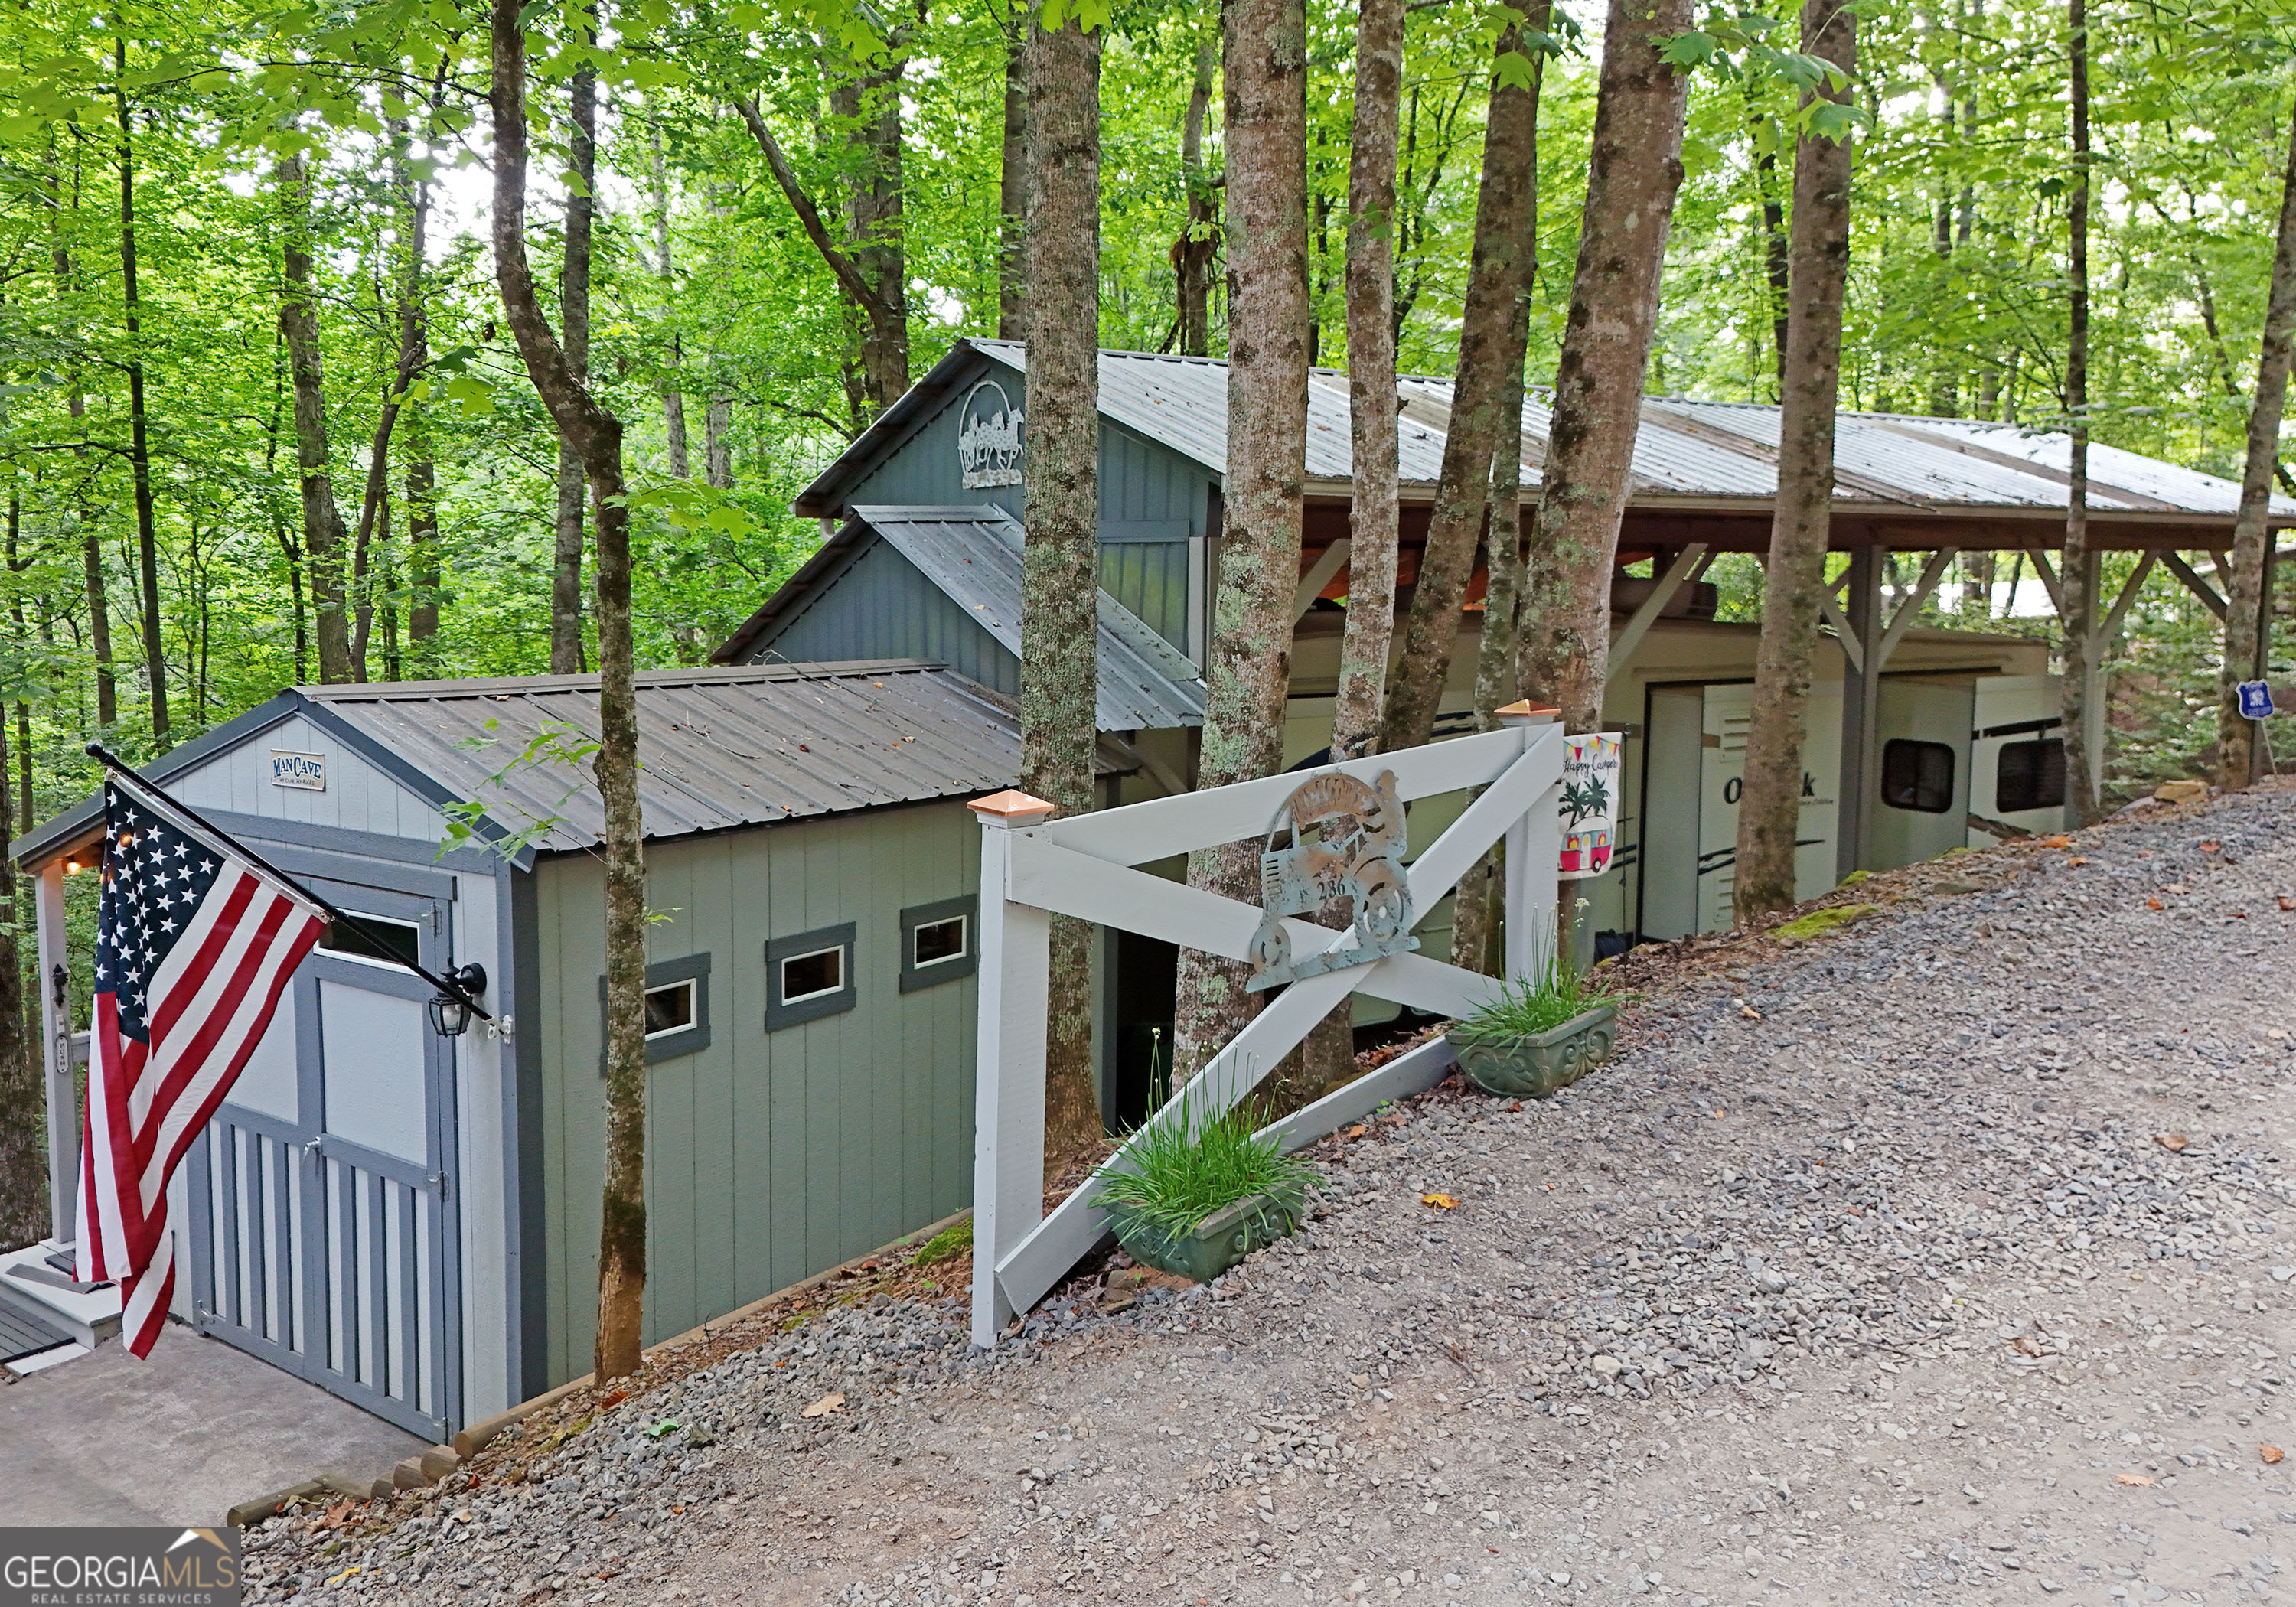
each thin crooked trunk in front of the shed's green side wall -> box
[487,0,645,1380]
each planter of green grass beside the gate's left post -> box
[1093,1093,1322,1283]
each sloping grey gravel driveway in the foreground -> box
[248,787,2296,1607]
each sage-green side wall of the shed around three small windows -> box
[533,801,980,1389]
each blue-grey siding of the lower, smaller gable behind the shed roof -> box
[762,533,1019,698]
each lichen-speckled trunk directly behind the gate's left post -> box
[1019,0,1102,1169]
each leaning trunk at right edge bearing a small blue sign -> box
[2216,100,2296,792]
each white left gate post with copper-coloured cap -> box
[971,790,1054,1345]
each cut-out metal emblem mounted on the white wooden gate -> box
[1244,769,1419,992]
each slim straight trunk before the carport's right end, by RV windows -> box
[2057,0,2103,826]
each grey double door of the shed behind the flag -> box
[191,882,461,1442]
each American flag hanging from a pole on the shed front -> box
[78,778,326,1357]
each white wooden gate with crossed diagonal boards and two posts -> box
[974,702,1564,1345]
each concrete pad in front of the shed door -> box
[0,1322,427,1524]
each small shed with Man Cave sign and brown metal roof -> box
[11,661,1065,1439]
